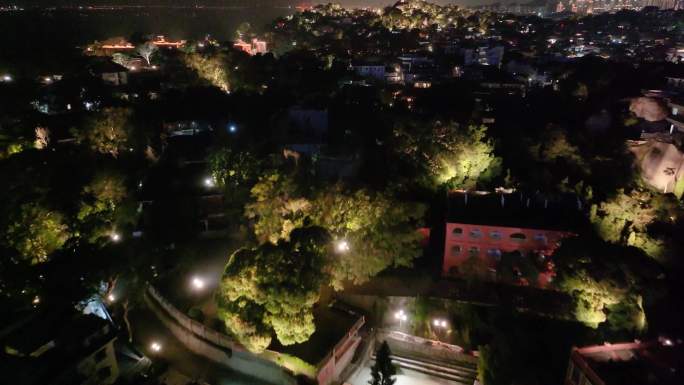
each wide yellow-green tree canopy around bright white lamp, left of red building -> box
[245,173,426,289]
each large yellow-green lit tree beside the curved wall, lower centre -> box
[217,227,330,352]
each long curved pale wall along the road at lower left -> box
[145,287,297,385]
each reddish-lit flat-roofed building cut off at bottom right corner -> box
[564,337,684,385]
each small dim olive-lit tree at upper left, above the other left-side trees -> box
[75,107,132,157]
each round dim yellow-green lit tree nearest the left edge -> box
[5,203,71,264]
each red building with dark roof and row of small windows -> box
[442,194,579,287]
